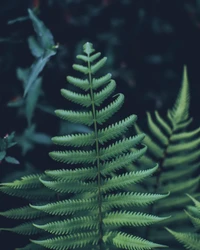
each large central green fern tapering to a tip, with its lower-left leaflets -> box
[1,43,171,250]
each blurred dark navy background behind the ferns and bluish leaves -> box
[0,0,200,250]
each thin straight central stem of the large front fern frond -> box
[88,55,103,250]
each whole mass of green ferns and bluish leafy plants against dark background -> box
[0,3,200,250]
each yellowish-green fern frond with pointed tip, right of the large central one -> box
[133,65,200,247]
